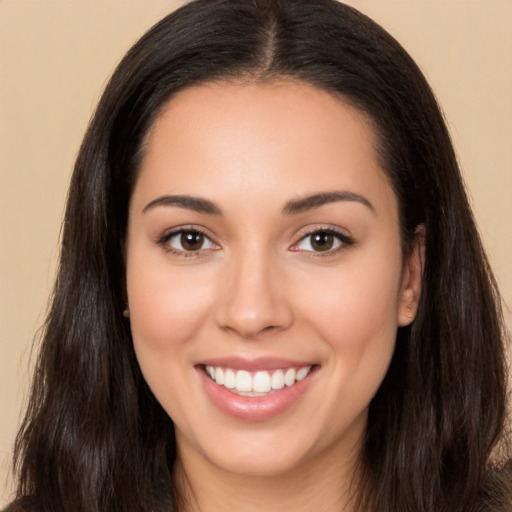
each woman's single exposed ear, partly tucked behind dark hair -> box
[398,224,425,327]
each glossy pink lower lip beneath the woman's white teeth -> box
[197,367,316,421]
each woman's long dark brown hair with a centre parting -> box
[8,0,512,512]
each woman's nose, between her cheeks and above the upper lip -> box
[216,251,293,339]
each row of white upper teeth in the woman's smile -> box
[204,365,313,397]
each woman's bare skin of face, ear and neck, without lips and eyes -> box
[126,82,422,512]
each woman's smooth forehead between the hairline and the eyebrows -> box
[136,82,394,218]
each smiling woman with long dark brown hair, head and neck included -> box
[8,0,512,512]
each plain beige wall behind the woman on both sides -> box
[0,0,512,506]
